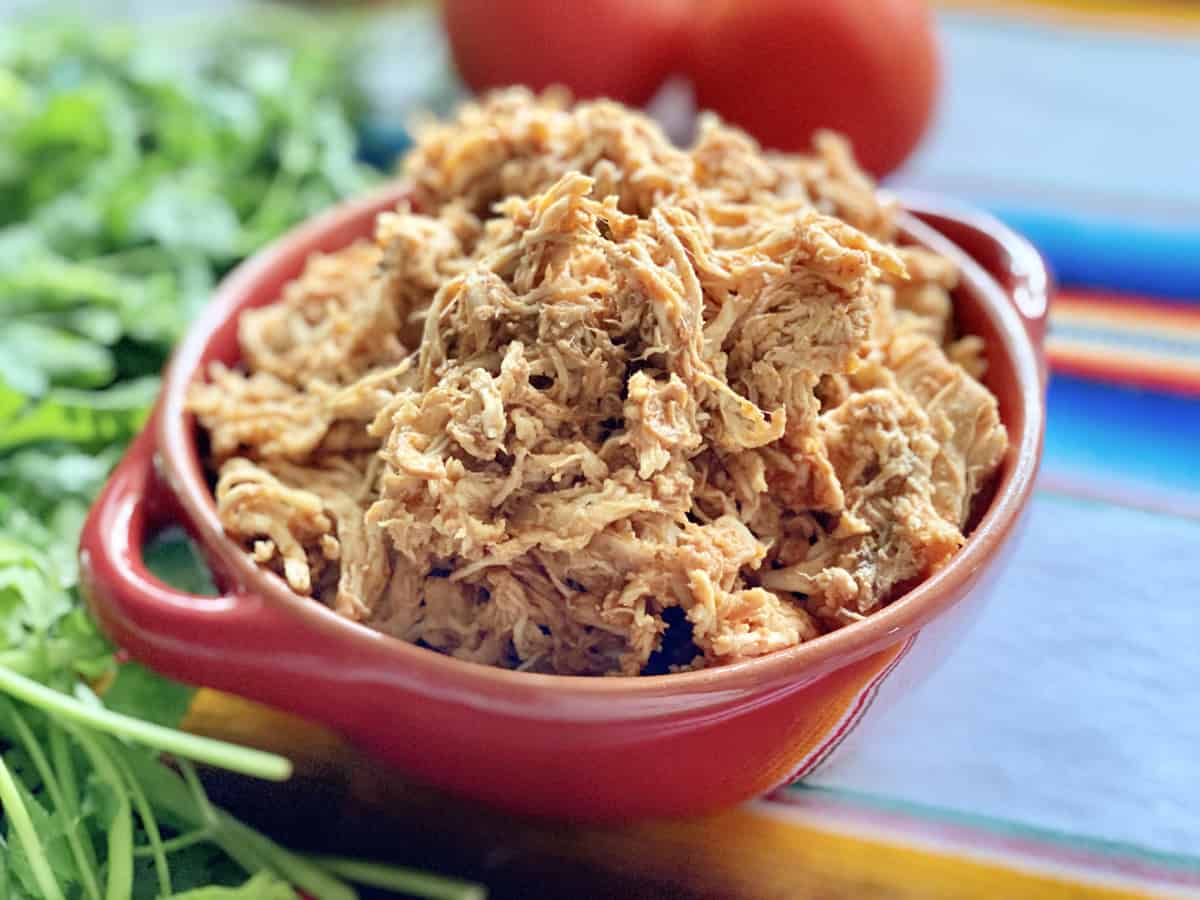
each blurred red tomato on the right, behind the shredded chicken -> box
[688,0,938,175]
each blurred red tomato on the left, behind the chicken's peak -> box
[443,0,690,104]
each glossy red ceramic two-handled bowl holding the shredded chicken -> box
[80,184,1048,820]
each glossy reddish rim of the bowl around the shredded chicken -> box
[157,181,1048,702]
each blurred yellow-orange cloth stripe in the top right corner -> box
[936,0,1200,35]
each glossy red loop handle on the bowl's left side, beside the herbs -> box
[79,410,312,692]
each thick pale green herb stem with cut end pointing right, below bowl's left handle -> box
[0,667,292,781]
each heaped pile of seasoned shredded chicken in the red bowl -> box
[190,90,1007,674]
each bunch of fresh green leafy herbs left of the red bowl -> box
[0,12,480,900]
